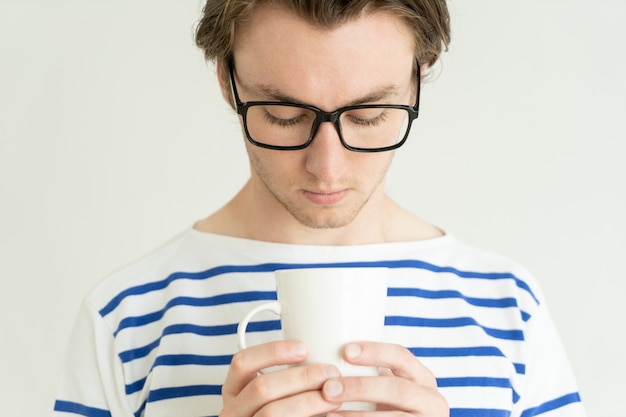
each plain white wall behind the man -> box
[0,0,626,417]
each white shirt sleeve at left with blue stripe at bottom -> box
[53,303,134,417]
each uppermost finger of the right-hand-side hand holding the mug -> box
[344,342,437,388]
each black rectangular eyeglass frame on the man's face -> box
[229,60,421,153]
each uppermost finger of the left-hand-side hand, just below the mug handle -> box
[222,341,307,398]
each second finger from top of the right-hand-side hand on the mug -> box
[322,376,448,416]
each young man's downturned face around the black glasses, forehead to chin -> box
[224,6,415,228]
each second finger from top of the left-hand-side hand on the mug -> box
[229,364,340,416]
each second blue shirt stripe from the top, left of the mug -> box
[114,291,276,336]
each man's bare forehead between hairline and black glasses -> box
[234,6,414,107]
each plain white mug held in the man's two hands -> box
[237,268,388,410]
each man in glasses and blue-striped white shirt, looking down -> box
[55,0,584,417]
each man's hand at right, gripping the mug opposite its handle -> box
[322,342,450,417]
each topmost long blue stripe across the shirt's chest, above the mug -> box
[99,259,539,317]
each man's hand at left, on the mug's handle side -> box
[220,341,341,417]
